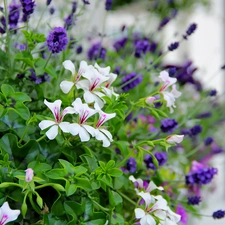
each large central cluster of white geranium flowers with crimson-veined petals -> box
[39,60,118,147]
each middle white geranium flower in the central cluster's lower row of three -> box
[69,98,97,142]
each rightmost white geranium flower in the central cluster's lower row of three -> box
[95,103,116,147]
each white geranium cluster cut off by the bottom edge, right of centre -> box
[129,176,181,225]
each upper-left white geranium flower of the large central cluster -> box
[60,60,89,94]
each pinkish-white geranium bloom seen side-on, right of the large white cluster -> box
[159,71,181,113]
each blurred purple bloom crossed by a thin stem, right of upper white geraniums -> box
[122,72,142,92]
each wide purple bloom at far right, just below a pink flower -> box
[185,167,218,186]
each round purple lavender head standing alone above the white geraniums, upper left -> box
[47,27,68,53]
